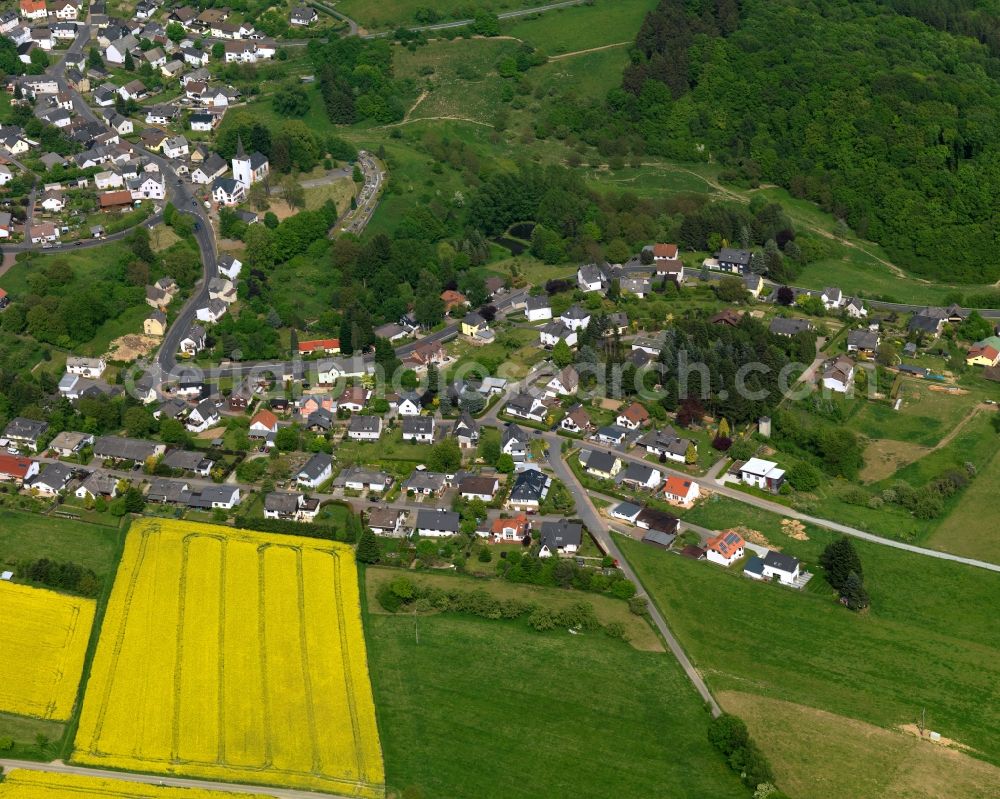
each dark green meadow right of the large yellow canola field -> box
[365,599,747,799]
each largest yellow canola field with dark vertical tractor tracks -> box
[73,519,385,797]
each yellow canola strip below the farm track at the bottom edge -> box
[0,769,278,799]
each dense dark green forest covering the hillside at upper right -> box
[546,0,1000,282]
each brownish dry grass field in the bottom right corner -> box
[717,691,1000,799]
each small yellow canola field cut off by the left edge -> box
[0,582,96,721]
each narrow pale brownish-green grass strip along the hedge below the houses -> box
[365,564,663,652]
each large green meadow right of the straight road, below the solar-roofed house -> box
[620,528,1000,763]
